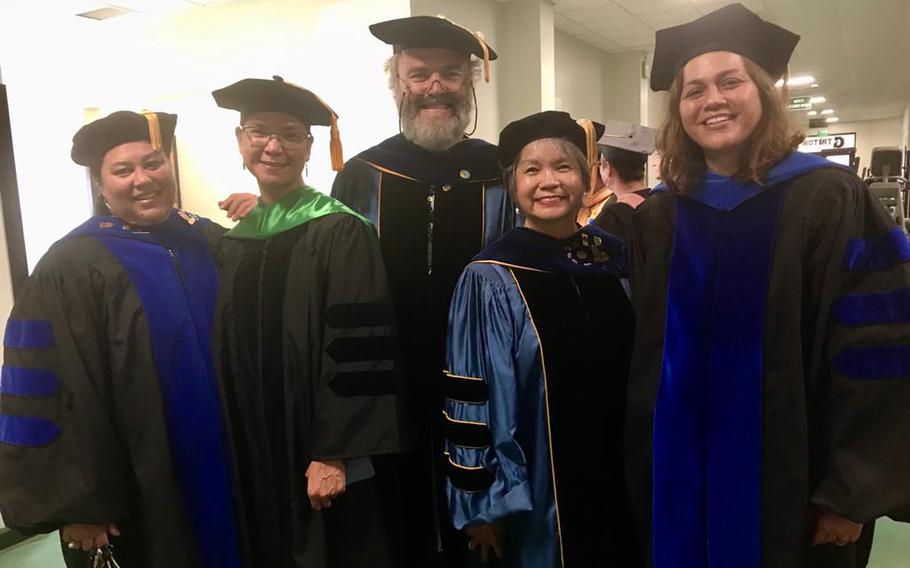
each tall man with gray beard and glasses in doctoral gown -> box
[332,16,515,568]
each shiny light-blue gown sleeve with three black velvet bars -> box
[443,264,533,529]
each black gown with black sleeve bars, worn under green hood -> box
[215,204,403,568]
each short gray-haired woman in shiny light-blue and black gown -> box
[444,111,642,568]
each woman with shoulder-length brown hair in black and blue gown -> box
[626,4,910,568]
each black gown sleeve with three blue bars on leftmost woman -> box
[0,246,128,534]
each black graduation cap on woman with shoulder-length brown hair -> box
[651,3,799,91]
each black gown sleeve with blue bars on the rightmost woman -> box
[807,172,910,522]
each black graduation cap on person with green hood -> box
[212,75,344,172]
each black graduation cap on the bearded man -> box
[370,16,498,83]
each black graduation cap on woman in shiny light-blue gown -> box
[498,110,589,168]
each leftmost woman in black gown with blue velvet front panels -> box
[0,111,241,568]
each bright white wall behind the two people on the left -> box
[0,0,410,267]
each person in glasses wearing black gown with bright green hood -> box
[212,77,403,568]
